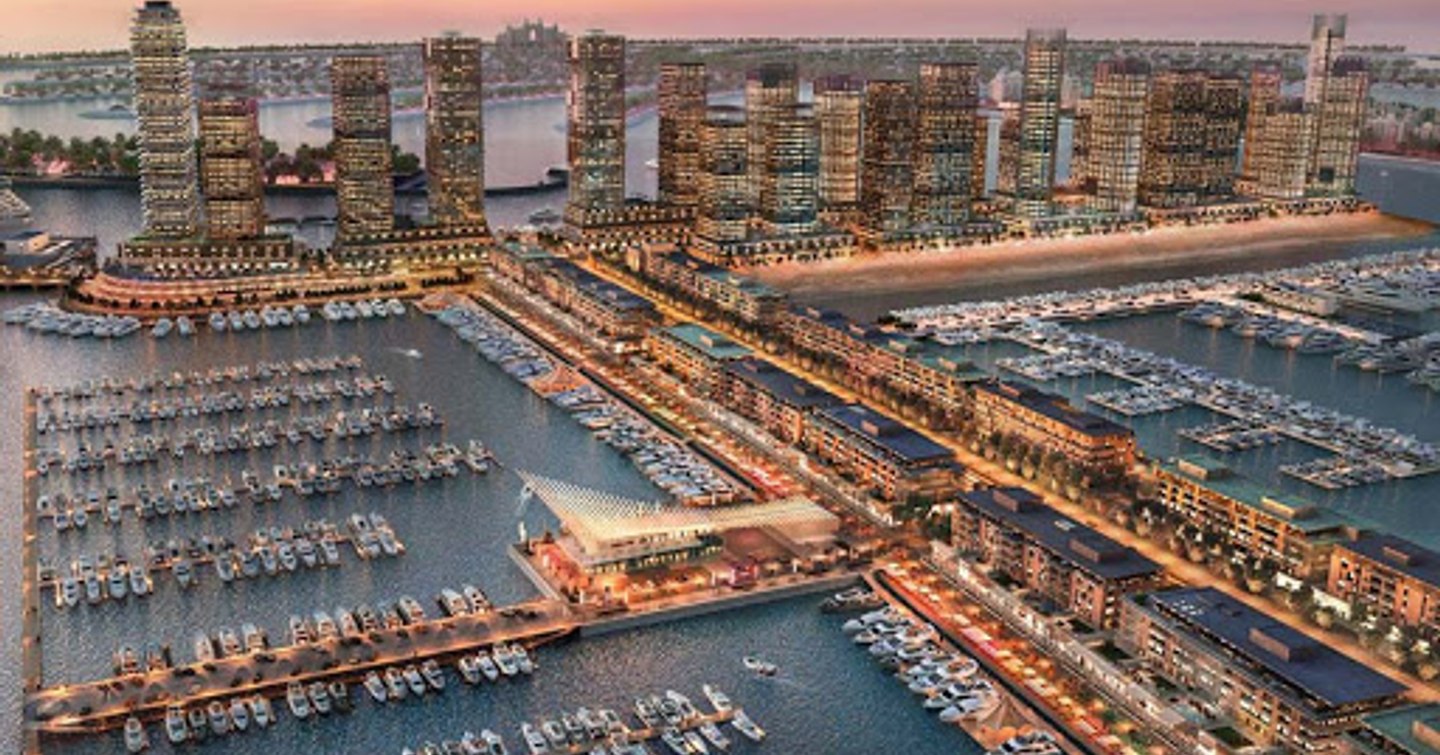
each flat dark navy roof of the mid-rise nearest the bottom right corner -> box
[1148,588,1405,707]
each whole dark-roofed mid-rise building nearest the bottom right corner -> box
[1116,588,1405,752]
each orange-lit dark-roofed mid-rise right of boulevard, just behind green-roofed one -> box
[972,380,1135,471]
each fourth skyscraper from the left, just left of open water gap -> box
[423,35,485,226]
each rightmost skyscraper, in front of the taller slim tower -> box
[1308,56,1369,196]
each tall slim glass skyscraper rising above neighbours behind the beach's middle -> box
[1015,29,1066,218]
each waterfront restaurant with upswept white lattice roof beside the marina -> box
[520,473,840,592]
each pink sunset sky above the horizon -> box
[0,0,1440,52]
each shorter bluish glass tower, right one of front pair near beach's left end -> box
[760,104,819,236]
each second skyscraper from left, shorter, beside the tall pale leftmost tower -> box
[200,94,265,239]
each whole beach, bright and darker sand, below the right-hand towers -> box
[744,212,1436,317]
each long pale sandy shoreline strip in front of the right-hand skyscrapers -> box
[746,213,1436,300]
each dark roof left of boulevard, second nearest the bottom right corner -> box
[960,487,1161,579]
